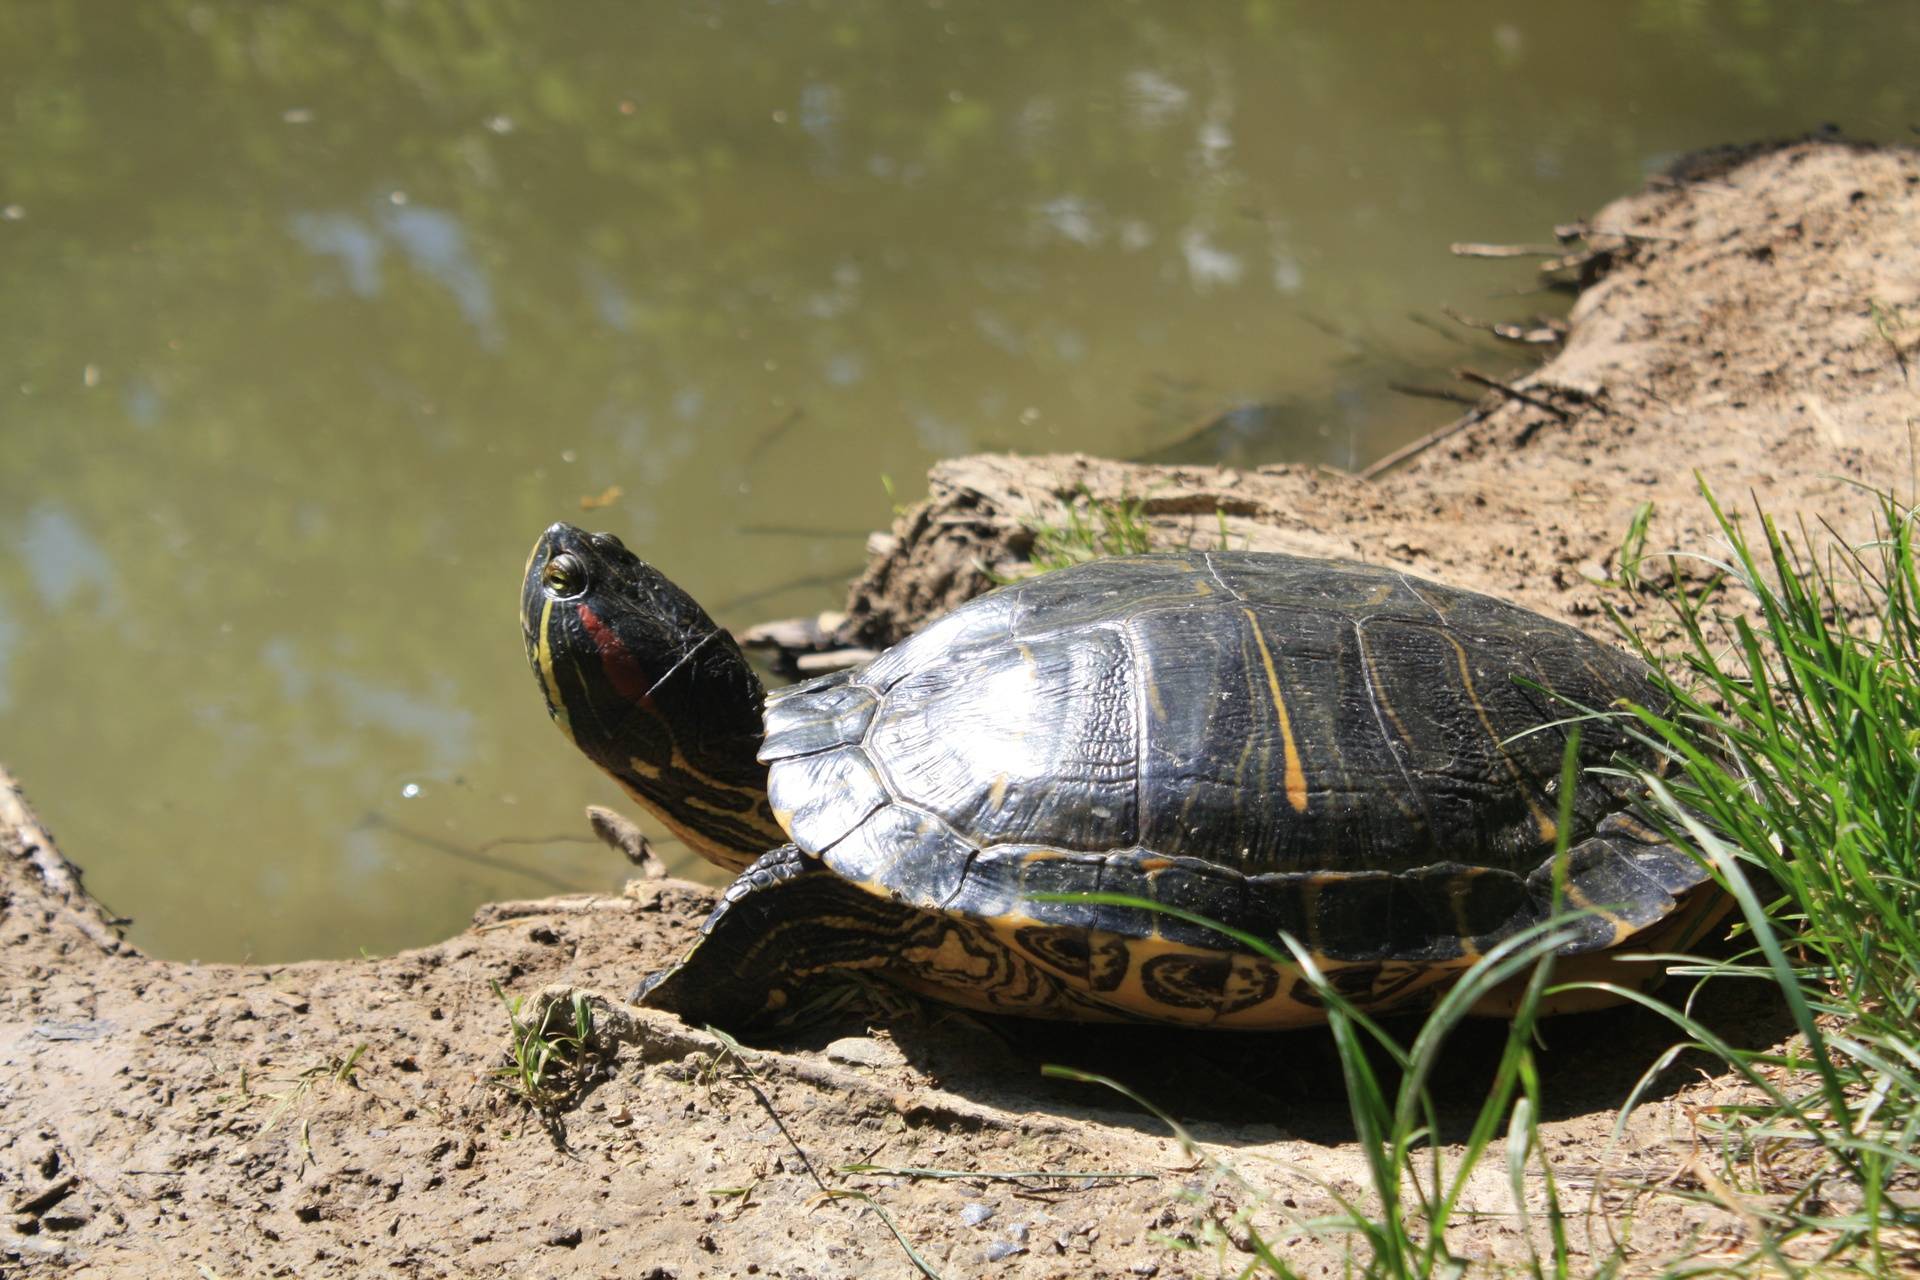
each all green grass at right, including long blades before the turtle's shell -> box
[1054,487,1920,1280]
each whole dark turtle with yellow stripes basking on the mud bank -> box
[520,524,1716,1027]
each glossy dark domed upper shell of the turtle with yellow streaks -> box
[760,553,1701,1013]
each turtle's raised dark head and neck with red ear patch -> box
[520,524,785,871]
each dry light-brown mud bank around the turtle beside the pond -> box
[11,142,1920,1280]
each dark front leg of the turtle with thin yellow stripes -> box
[634,844,924,1029]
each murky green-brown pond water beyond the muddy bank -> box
[11,0,1920,960]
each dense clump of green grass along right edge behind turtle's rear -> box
[1605,479,1920,1274]
